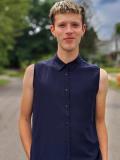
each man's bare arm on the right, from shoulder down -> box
[96,69,108,160]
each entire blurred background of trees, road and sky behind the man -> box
[0,0,120,160]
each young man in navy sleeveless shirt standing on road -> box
[19,0,108,160]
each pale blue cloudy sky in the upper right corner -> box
[91,0,120,40]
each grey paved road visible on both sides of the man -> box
[0,79,120,160]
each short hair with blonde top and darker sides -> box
[49,0,85,24]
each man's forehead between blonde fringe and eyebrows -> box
[54,13,82,23]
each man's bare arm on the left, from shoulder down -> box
[19,64,34,160]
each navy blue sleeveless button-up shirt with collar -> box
[30,54,102,160]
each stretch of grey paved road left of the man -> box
[0,79,25,160]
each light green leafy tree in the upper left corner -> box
[0,0,30,65]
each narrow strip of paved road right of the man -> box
[106,89,120,160]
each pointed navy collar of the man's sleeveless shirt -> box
[53,54,81,71]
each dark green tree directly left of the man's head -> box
[11,0,56,67]
